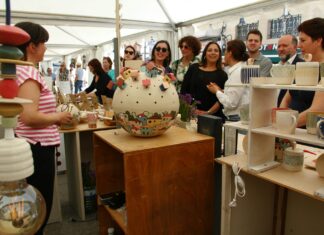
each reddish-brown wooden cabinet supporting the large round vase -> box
[94,127,214,235]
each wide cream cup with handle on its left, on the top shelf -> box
[270,65,295,85]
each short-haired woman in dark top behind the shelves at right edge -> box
[280,17,324,127]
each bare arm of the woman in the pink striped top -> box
[18,79,72,128]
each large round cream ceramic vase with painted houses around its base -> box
[112,72,179,137]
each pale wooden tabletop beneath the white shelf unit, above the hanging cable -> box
[216,154,324,202]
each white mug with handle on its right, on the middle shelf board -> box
[276,110,298,134]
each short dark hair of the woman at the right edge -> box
[297,17,324,49]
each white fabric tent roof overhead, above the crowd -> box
[0,0,269,56]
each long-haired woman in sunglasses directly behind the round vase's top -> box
[144,40,172,74]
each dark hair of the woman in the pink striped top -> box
[15,22,49,59]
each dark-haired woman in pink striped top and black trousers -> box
[15,22,72,234]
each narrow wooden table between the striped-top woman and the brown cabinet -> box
[60,121,115,220]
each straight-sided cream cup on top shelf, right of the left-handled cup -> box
[295,62,319,86]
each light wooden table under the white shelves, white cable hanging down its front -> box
[216,154,324,235]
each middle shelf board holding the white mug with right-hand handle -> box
[251,126,324,147]
